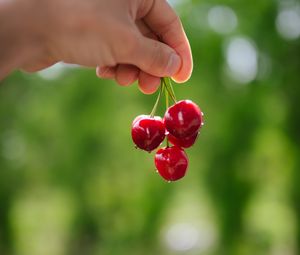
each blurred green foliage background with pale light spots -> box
[0,0,300,255]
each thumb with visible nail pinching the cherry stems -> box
[126,36,181,77]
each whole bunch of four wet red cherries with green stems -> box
[131,78,203,181]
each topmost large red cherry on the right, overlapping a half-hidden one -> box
[164,100,202,138]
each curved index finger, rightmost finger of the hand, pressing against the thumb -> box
[142,0,193,82]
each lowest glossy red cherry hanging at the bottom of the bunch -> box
[154,146,188,181]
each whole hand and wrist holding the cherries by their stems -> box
[0,0,193,94]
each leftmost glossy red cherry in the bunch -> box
[131,115,166,152]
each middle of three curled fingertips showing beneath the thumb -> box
[115,64,139,86]
